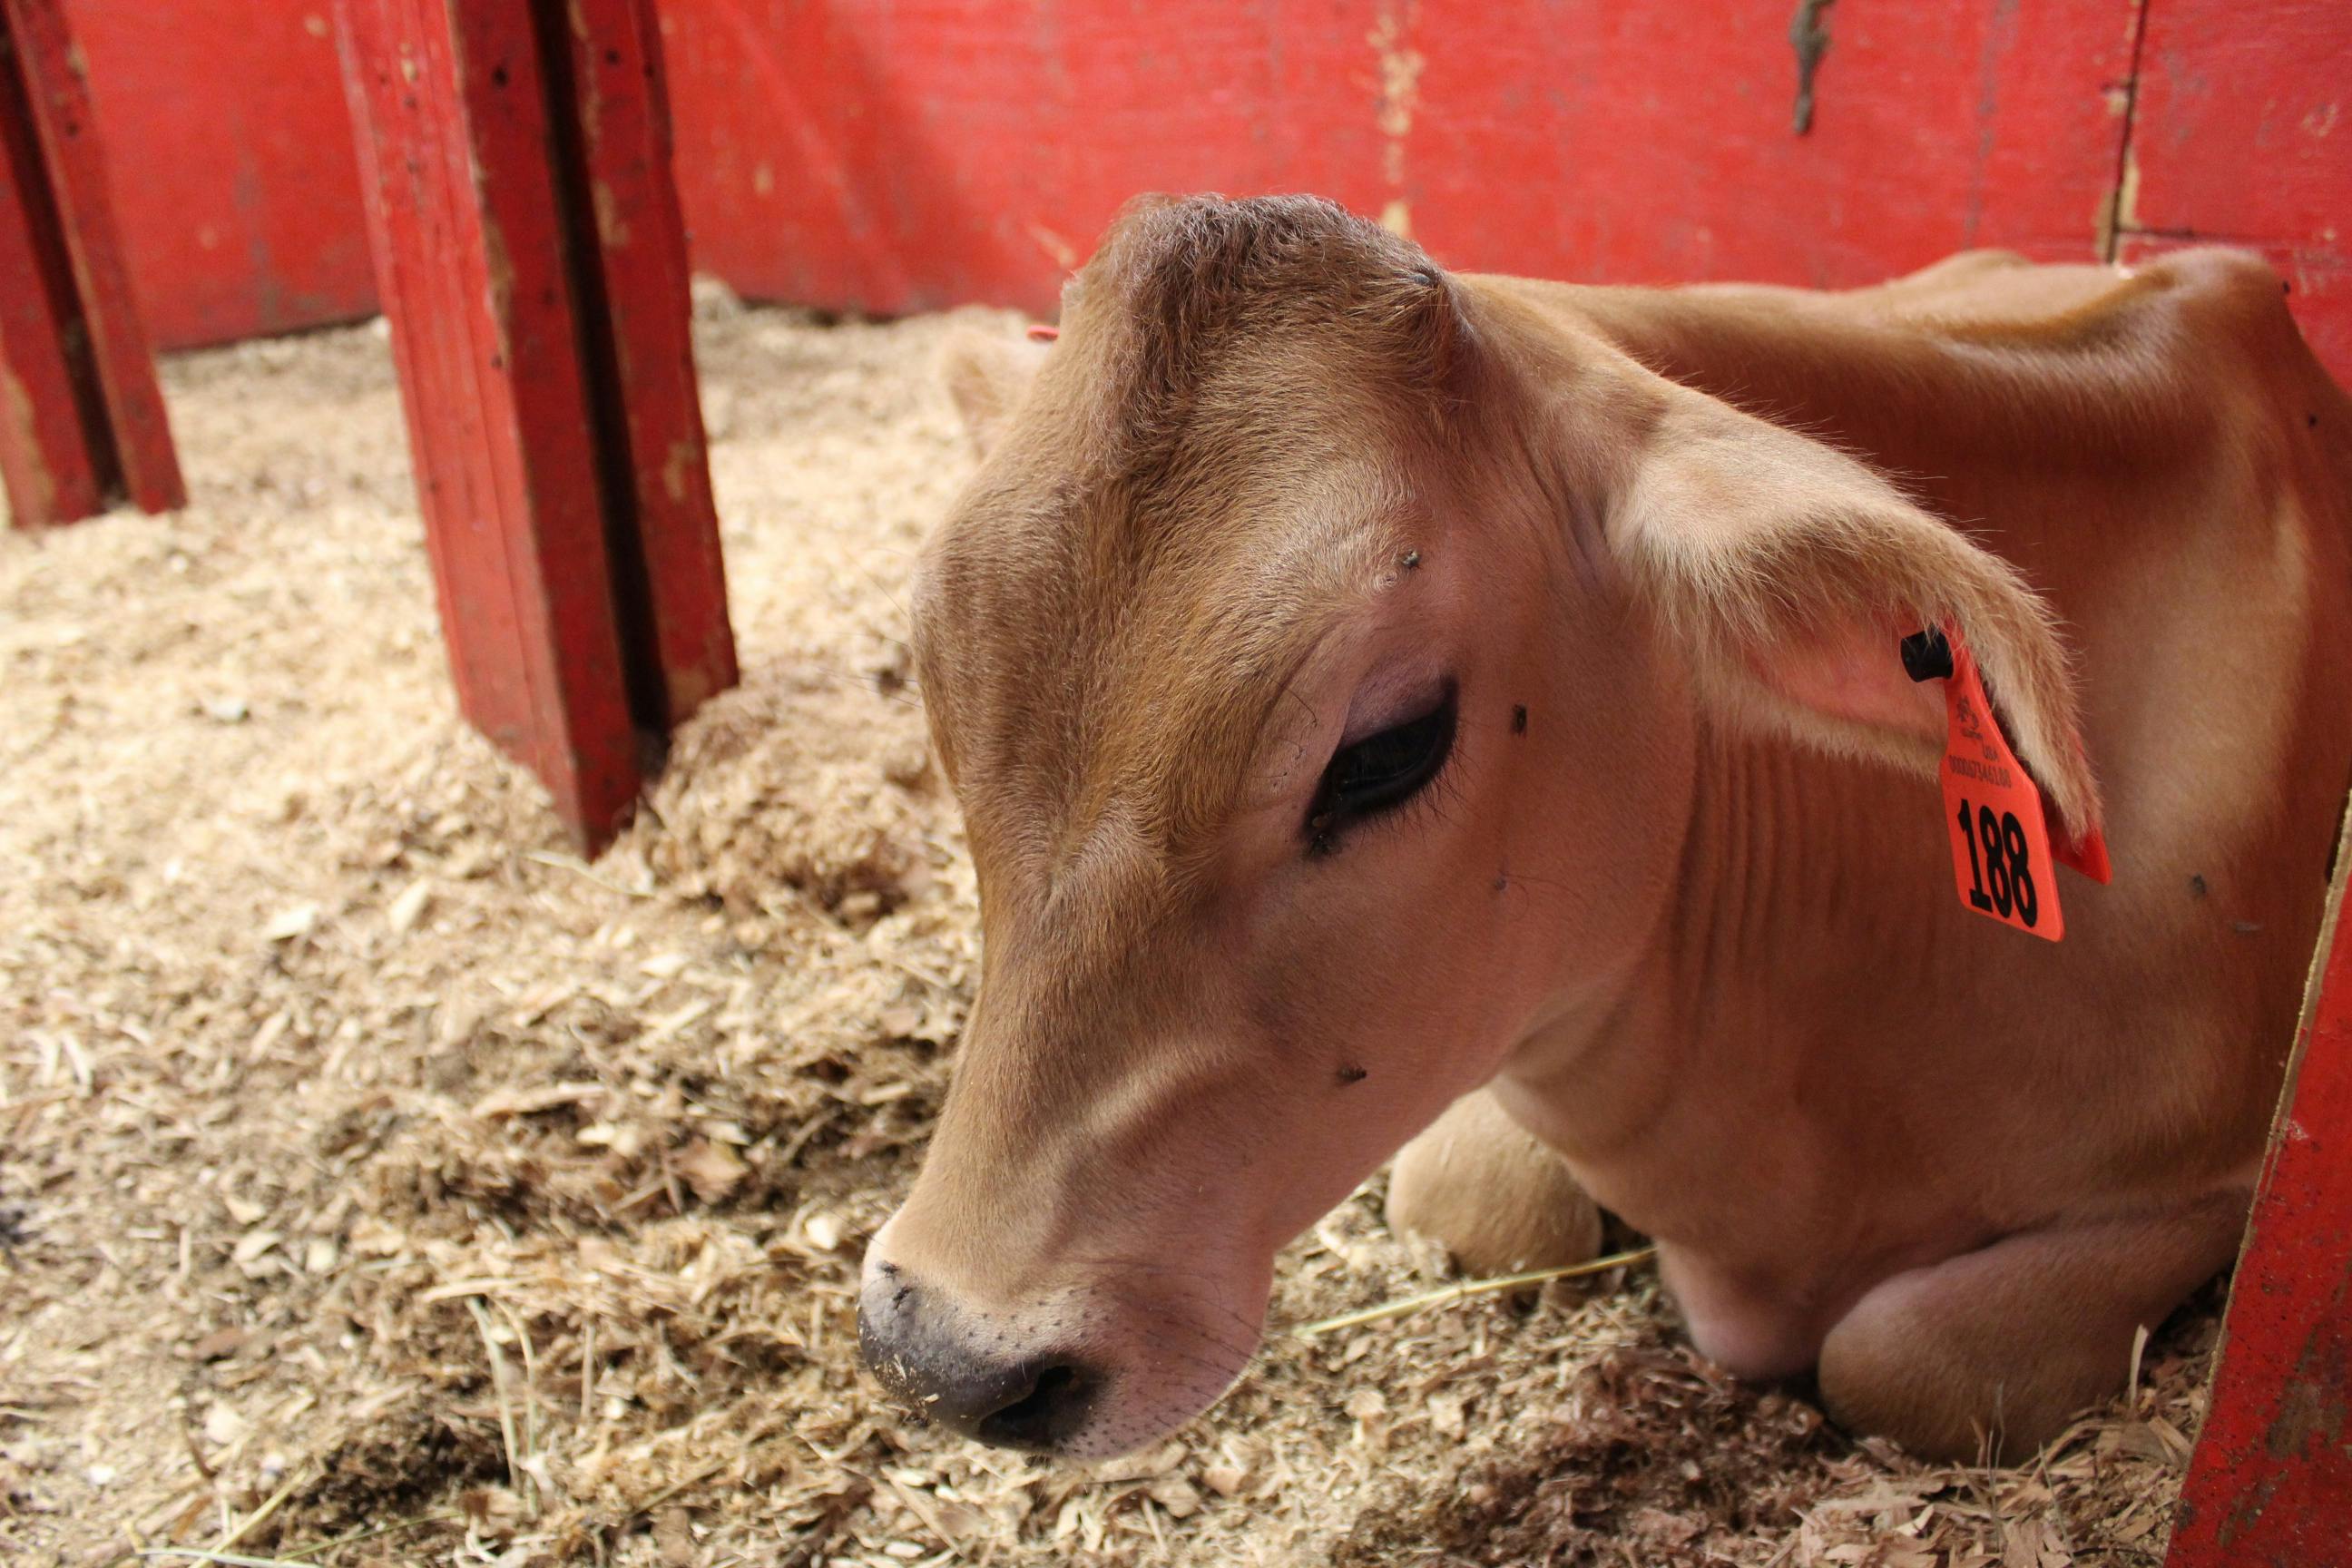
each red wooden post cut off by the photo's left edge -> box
[0,0,186,526]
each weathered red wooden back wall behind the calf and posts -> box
[68,0,2352,377]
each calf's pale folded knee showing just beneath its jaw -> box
[1387,1088,1602,1274]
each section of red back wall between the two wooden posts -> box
[66,0,377,348]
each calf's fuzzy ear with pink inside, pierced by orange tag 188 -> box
[1606,386,2101,841]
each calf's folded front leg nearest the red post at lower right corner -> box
[1820,1191,2249,1462]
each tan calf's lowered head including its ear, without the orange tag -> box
[861,200,2095,1455]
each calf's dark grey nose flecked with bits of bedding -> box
[858,1262,1103,1453]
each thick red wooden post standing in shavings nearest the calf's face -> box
[337,0,736,851]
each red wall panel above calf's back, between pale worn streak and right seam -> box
[1392,0,2136,287]
